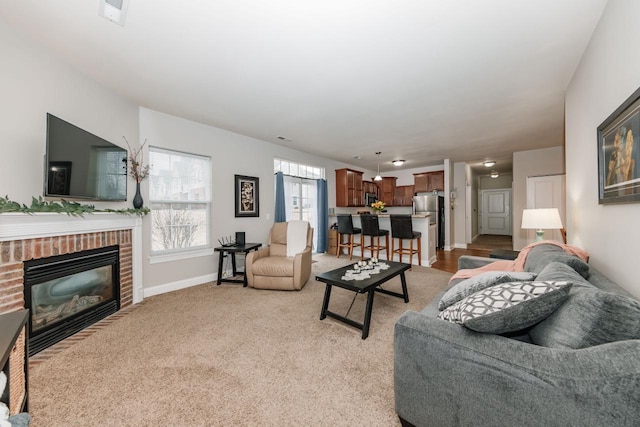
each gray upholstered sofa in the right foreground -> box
[394,245,640,426]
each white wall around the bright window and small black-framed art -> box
[140,108,355,293]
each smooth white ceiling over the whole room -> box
[0,0,606,171]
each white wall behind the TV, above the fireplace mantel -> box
[0,20,138,209]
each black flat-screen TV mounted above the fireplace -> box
[44,113,127,201]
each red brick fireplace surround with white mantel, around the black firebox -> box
[0,214,142,332]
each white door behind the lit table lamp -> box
[527,175,566,243]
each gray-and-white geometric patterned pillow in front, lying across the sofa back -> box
[438,281,572,334]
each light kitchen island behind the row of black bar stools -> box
[329,213,436,267]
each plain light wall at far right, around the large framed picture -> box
[565,0,640,296]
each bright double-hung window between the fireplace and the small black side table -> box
[149,147,211,254]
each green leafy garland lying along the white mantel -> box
[0,196,150,216]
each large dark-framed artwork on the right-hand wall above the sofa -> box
[597,89,640,204]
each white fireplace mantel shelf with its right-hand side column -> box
[0,212,143,304]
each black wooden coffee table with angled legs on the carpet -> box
[316,261,411,340]
